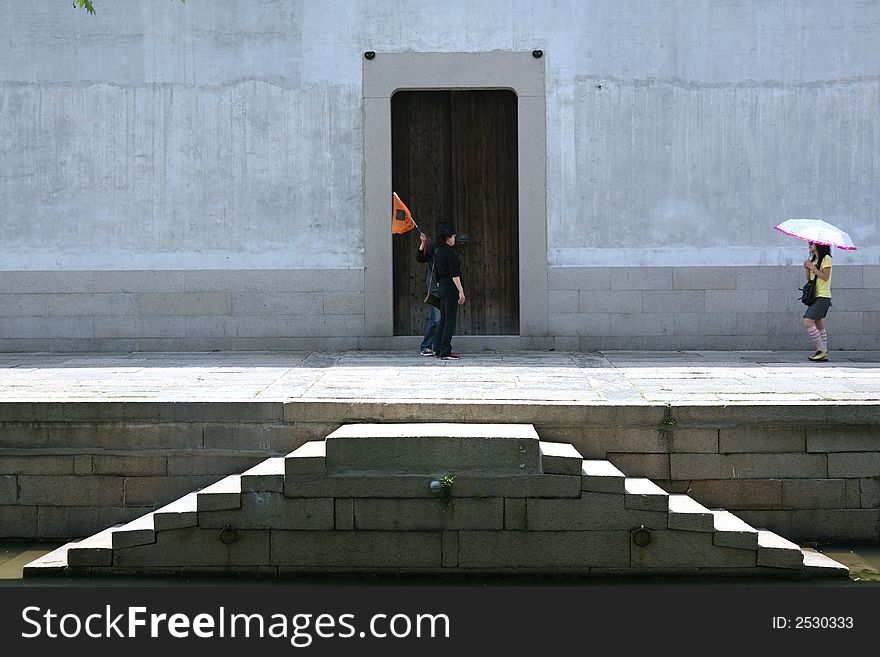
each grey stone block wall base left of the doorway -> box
[0,269,364,352]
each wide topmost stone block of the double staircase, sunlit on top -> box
[326,423,544,475]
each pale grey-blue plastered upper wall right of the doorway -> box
[548,0,880,266]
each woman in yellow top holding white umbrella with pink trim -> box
[776,219,856,362]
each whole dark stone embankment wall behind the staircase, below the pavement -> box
[0,402,880,542]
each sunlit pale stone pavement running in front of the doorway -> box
[0,351,880,405]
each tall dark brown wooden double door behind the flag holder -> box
[391,91,519,335]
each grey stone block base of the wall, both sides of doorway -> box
[0,265,880,352]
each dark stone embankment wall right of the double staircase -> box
[537,406,880,542]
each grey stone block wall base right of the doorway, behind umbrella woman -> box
[548,264,880,351]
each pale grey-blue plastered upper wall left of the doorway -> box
[0,0,363,270]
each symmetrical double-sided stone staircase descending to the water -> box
[24,424,848,577]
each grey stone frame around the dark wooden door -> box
[363,52,548,337]
